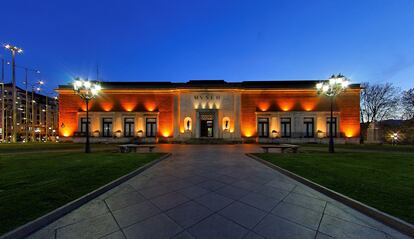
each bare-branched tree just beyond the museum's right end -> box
[360,83,399,142]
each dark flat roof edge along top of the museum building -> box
[58,80,360,90]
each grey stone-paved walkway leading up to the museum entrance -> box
[24,145,409,239]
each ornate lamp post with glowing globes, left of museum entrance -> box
[73,78,101,153]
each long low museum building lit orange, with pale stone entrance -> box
[57,80,360,143]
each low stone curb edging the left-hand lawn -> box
[0,153,171,239]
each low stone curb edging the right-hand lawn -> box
[246,154,414,237]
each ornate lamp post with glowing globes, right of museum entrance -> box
[316,74,349,153]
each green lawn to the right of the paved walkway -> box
[256,149,414,223]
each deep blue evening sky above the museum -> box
[0,0,414,91]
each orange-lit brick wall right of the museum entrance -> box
[241,90,359,137]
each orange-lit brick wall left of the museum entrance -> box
[59,91,174,136]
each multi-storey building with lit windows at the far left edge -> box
[0,84,59,141]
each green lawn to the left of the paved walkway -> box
[0,150,162,235]
